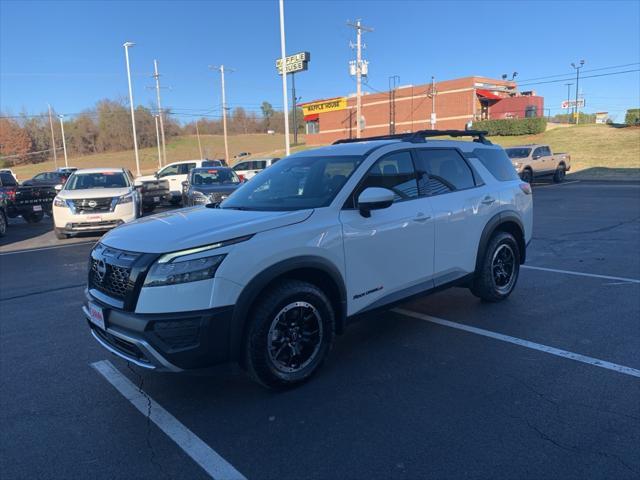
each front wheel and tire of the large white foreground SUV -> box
[243,280,335,389]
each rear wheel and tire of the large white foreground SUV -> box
[470,232,520,302]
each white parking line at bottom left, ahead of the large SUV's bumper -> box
[91,360,246,480]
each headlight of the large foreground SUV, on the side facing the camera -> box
[144,255,225,287]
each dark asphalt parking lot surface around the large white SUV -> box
[0,182,640,479]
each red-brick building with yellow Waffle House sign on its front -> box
[300,77,544,145]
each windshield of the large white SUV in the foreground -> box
[221,156,363,210]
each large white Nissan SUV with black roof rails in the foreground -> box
[83,131,533,388]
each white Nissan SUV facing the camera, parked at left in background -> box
[52,168,141,239]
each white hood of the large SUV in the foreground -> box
[101,206,313,253]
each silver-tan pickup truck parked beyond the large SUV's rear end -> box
[505,144,571,183]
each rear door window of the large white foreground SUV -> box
[416,149,476,195]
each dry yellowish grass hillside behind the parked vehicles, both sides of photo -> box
[14,124,640,180]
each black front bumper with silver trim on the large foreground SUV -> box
[82,291,234,372]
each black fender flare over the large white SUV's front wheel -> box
[229,255,347,358]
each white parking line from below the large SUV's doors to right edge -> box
[391,308,640,378]
